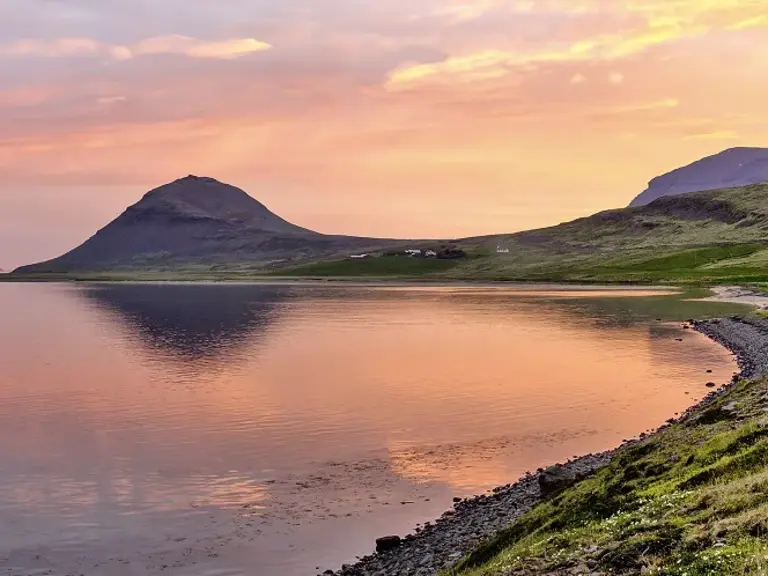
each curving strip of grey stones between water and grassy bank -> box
[325,316,768,576]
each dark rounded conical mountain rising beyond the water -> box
[16,176,391,273]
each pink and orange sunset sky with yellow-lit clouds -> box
[0,0,768,270]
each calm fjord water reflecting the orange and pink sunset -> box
[0,284,735,576]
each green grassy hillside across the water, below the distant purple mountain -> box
[444,184,768,282]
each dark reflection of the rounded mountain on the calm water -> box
[81,284,289,361]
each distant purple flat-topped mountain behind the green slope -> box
[630,148,768,206]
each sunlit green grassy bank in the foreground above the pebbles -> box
[442,379,768,576]
